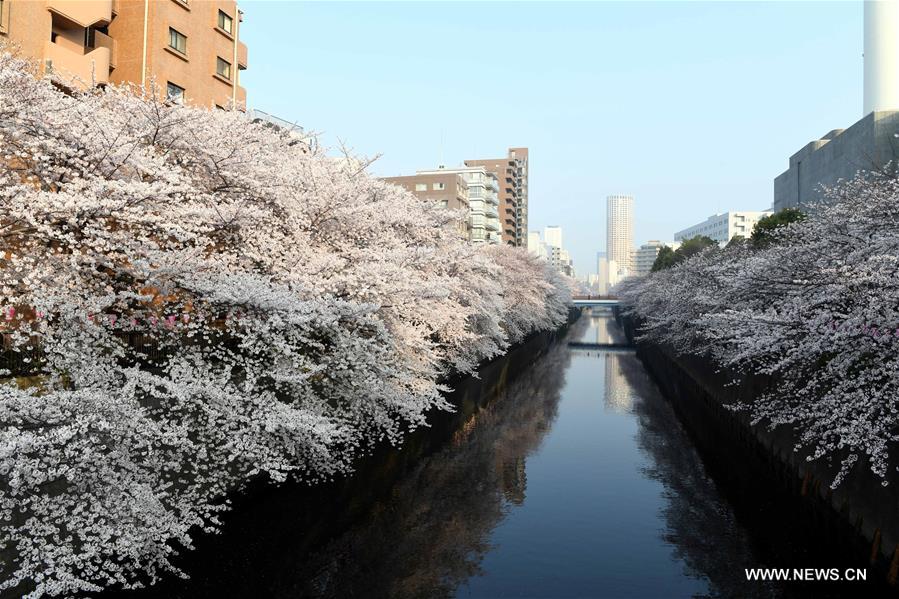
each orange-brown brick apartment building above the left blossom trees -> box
[0,0,247,109]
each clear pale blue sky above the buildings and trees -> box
[240,0,863,274]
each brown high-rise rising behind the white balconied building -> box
[465,148,528,247]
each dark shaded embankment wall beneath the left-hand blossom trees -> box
[91,309,581,599]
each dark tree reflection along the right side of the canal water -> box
[618,355,781,597]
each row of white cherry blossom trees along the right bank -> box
[622,173,899,487]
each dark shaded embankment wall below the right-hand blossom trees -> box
[619,317,899,589]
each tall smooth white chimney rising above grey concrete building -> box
[863,0,899,116]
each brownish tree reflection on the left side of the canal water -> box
[283,327,581,598]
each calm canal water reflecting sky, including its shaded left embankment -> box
[110,311,880,599]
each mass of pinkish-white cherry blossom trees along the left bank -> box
[0,49,569,597]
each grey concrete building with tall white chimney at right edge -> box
[772,0,899,211]
